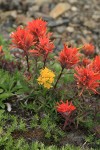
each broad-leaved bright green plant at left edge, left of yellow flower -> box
[0,70,29,107]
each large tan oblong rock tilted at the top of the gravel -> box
[50,3,71,18]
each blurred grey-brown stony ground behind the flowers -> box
[0,0,100,53]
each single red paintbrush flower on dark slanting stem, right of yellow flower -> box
[58,44,79,69]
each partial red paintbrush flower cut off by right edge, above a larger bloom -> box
[91,56,100,73]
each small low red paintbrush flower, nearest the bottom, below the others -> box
[56,100,76,114]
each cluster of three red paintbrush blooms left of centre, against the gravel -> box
[11,19,54,59]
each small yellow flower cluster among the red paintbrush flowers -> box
[37,67,55,89]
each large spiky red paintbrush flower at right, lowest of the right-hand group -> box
[74,66,100,93]
